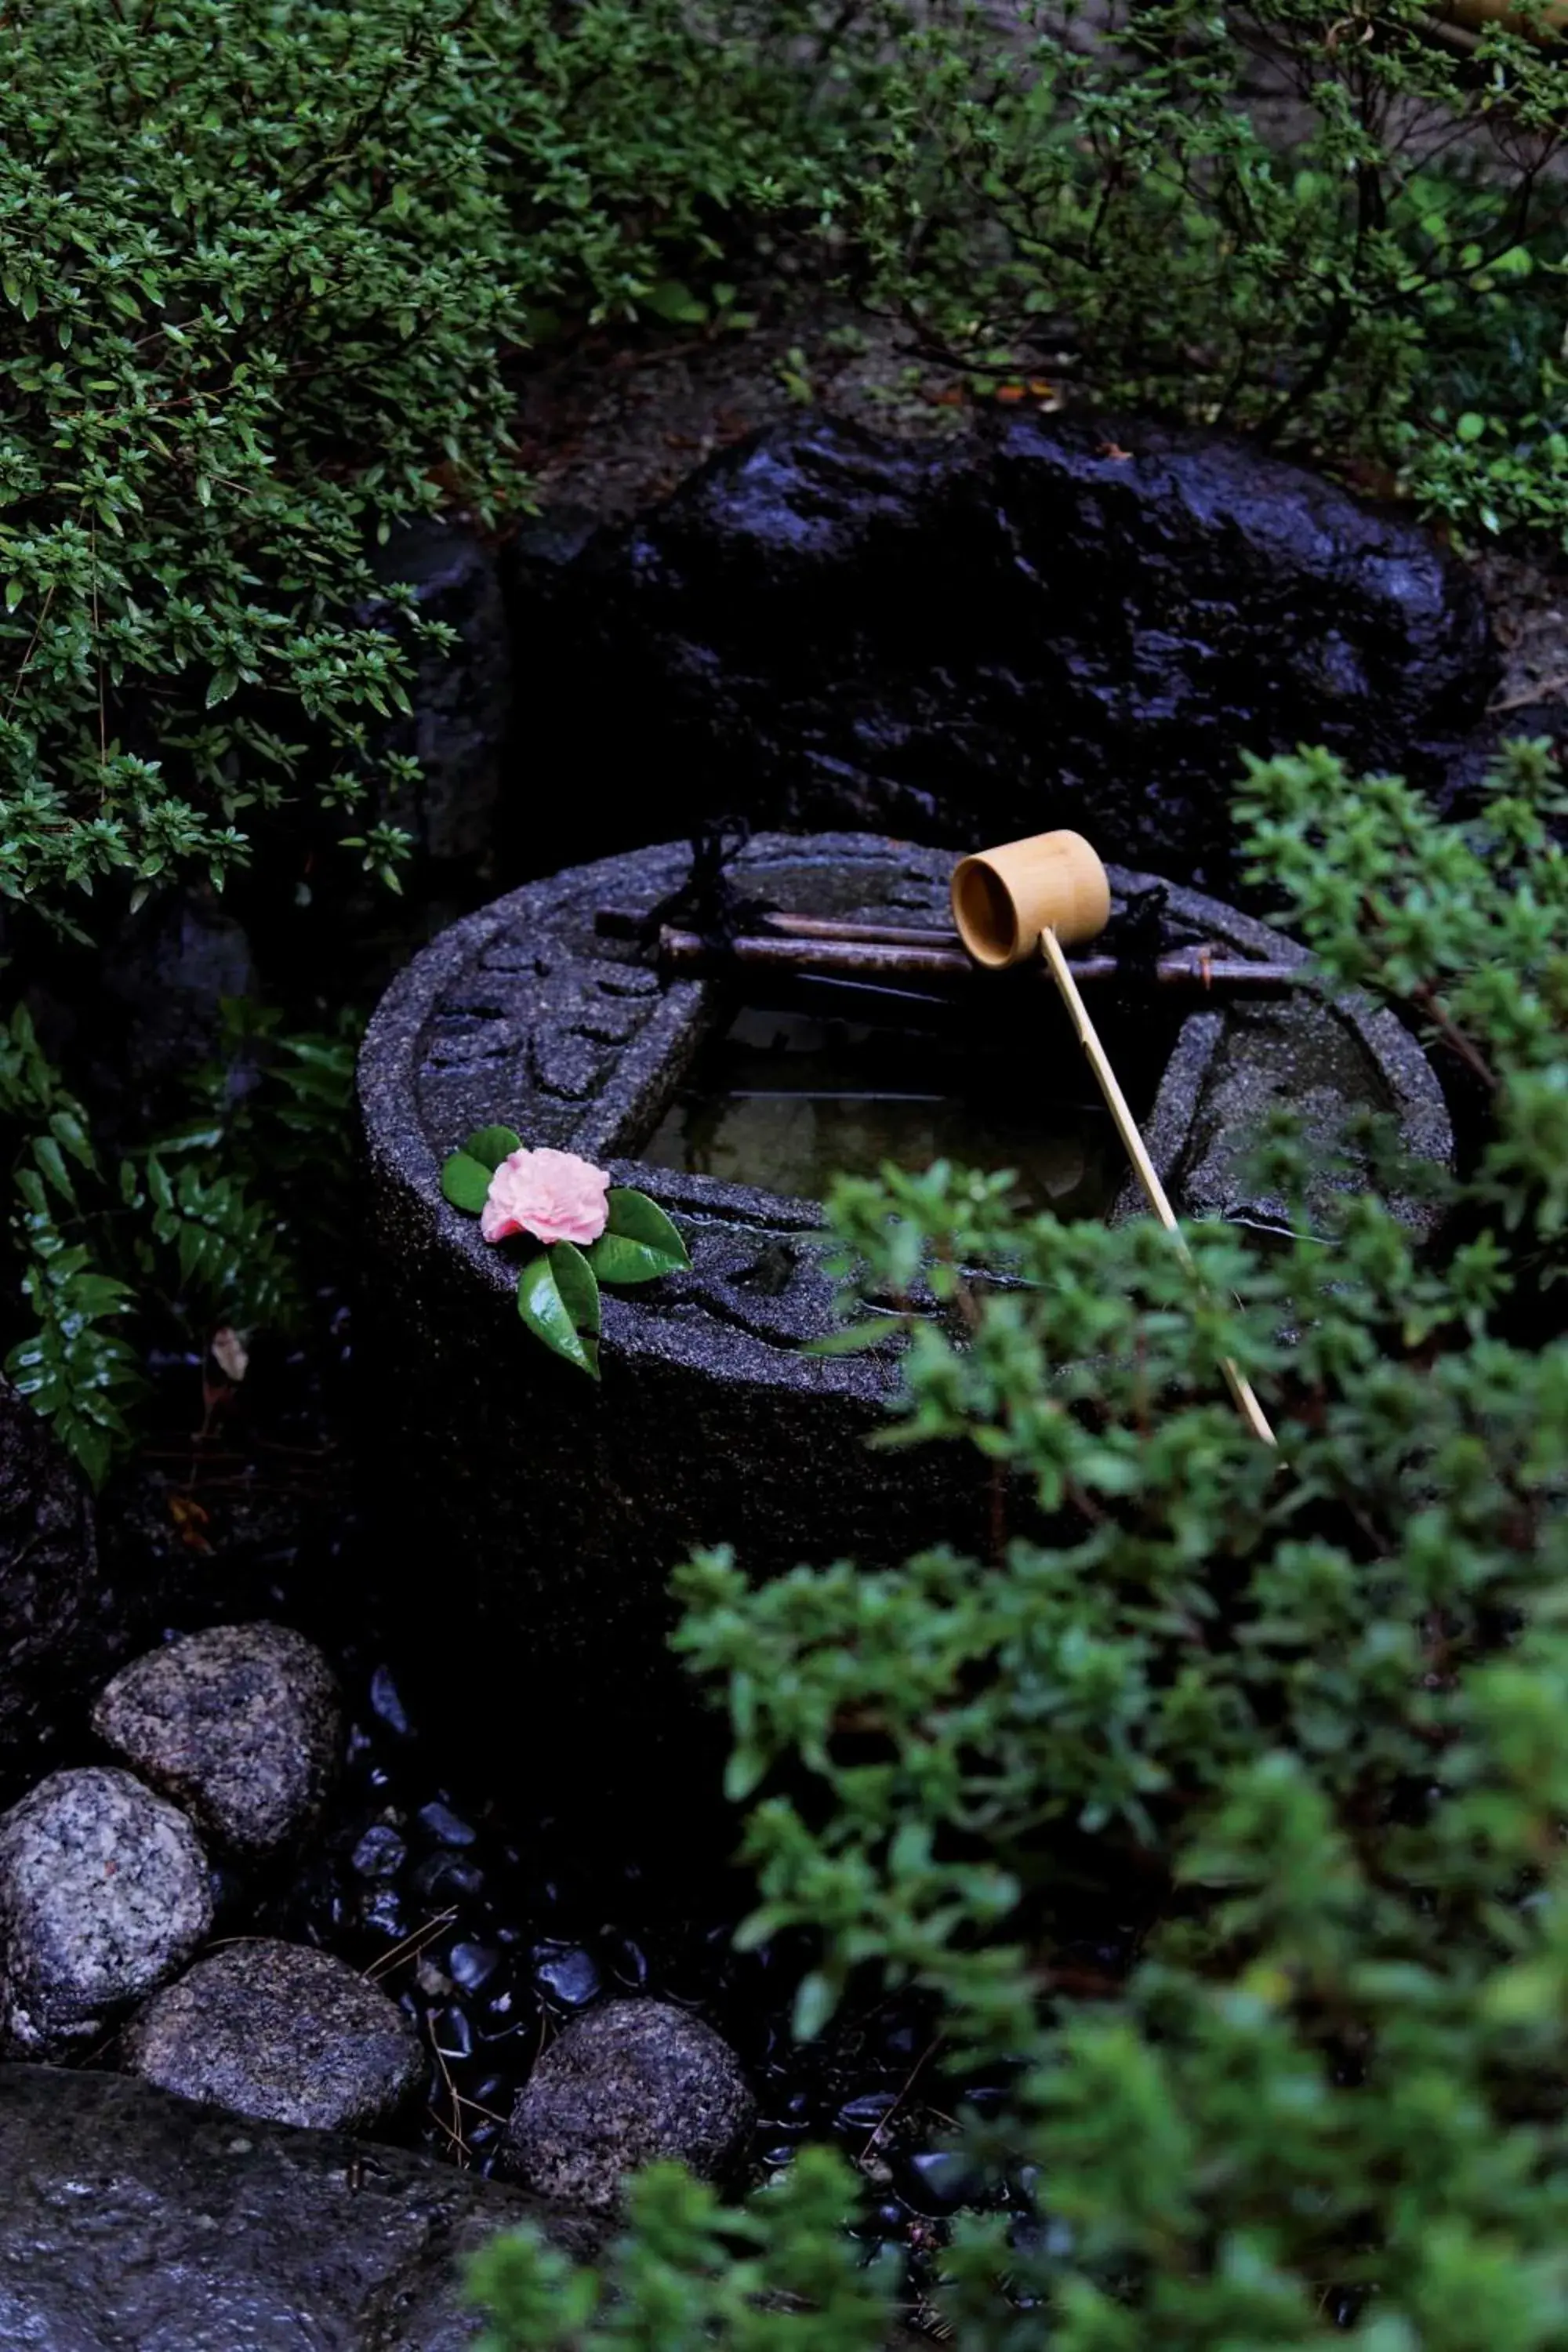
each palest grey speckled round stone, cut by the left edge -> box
[0,1766,212,2056]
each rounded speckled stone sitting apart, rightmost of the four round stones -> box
[506,2002,757,2213]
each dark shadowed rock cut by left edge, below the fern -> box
[0,1381,106,1778]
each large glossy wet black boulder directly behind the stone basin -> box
[503,419,1497,887]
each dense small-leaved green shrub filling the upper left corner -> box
[0,0,902,922]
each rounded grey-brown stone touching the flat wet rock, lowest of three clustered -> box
[125,1938,423,2131]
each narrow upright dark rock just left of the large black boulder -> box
[376,517,513,863]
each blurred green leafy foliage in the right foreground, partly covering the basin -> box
[475,746,1568,2352]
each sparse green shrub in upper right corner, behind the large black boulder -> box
[855,0,1568,536]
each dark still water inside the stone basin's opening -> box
[640,1007,1126,1216]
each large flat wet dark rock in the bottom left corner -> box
[0,2065,597,2352]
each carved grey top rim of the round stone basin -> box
[360,835,1450,1397]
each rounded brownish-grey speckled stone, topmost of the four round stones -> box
[92,1623,341,1856]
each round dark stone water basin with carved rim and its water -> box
[360,835,1450,1712]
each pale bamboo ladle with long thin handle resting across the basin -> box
[952,833,1276,1446]
